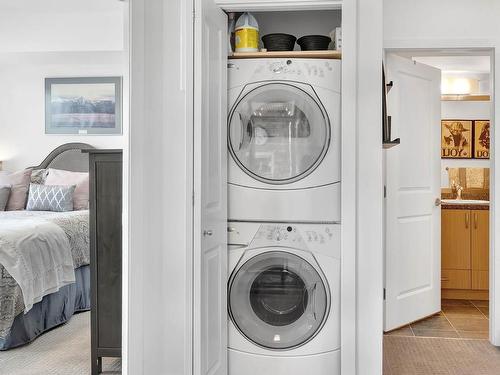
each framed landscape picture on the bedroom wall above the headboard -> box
[45,77,122,135]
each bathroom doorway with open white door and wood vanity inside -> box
[384,50,495,374]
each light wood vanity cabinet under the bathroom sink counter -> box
[441,209,489,298]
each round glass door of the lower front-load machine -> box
[228,251,330,350]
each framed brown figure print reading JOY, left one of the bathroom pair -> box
[441,120,472,159]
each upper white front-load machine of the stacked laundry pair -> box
[228,58,341,222]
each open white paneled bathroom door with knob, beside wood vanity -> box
[384,55,441,331]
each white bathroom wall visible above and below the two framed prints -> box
[441,101,491,187]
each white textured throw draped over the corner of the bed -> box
[0,211,75,313]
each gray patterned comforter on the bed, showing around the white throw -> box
[0,211,90,338]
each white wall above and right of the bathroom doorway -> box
[384,0,500,345]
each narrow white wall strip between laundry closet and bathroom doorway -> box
[356,0,384,375]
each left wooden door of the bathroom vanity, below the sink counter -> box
[441,209,472,270]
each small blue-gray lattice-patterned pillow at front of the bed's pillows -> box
[26,184,76,212]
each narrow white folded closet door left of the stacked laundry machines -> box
[193,0,227,375]
